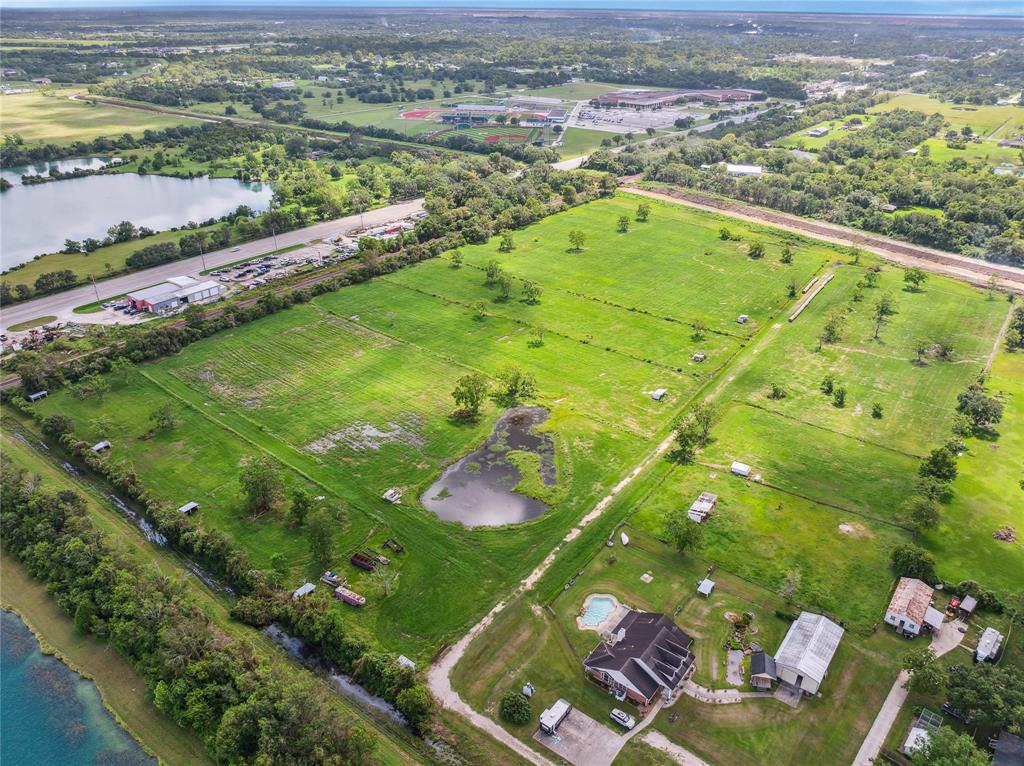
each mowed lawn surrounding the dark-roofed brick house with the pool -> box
[453,527,904,766]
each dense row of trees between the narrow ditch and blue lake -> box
[0,459,377,766]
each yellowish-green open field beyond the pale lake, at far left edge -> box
[0,92,199,143]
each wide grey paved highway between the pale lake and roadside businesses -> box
[0,199,423,332]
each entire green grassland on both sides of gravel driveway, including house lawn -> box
[8,188,1024,764]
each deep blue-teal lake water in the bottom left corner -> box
[0,610,157,766]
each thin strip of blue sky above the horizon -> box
[2,0,1024,16]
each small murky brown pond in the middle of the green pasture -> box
[420,407,556,527]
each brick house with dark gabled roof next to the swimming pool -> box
[583,609,694,707]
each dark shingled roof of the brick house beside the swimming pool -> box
[584,611,693,699]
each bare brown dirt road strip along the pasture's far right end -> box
[624,185,1024,294]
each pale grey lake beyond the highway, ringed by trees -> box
[0,168,273,269]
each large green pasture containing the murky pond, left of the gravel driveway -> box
[29,197,827,652]
